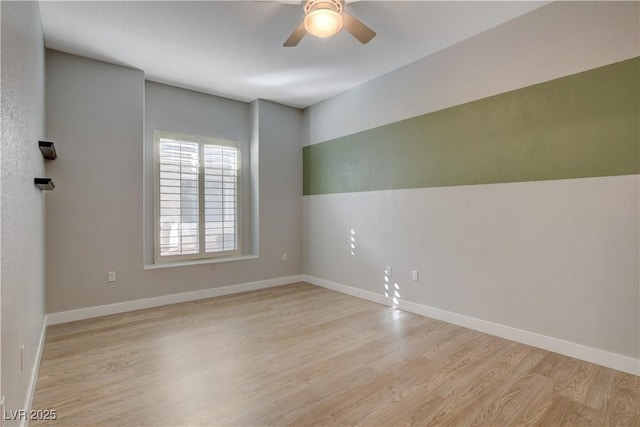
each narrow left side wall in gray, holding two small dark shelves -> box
[0,2,50,425]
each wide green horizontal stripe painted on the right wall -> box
[303,58,640,195]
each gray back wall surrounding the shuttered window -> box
[46,50,302,313]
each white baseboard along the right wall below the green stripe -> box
[302,275,640,376]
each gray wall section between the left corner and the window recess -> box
[46,50,144,312]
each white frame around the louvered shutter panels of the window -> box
[153,130,242,264]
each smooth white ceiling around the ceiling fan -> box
[41,0,546,107]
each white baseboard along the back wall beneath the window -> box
[46,275,302,325]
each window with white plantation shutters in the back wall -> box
[154,131,240,262]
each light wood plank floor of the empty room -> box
[30,283,640,426]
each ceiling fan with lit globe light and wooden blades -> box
[283,0,376,47]
